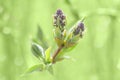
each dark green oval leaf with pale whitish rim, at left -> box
[32,43,45,59]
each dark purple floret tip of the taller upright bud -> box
[53,9,66,29]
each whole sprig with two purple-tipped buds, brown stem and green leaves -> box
[27,9,85,74]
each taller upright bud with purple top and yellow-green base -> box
[53,9,66,46]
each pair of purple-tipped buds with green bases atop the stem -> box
[53,9,85,48]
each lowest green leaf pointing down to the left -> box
[25,64,45,73]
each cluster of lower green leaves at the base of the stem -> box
[29,43,53,74]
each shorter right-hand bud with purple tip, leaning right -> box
[65,22,84,48]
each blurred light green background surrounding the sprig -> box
[0,0,120,80]
